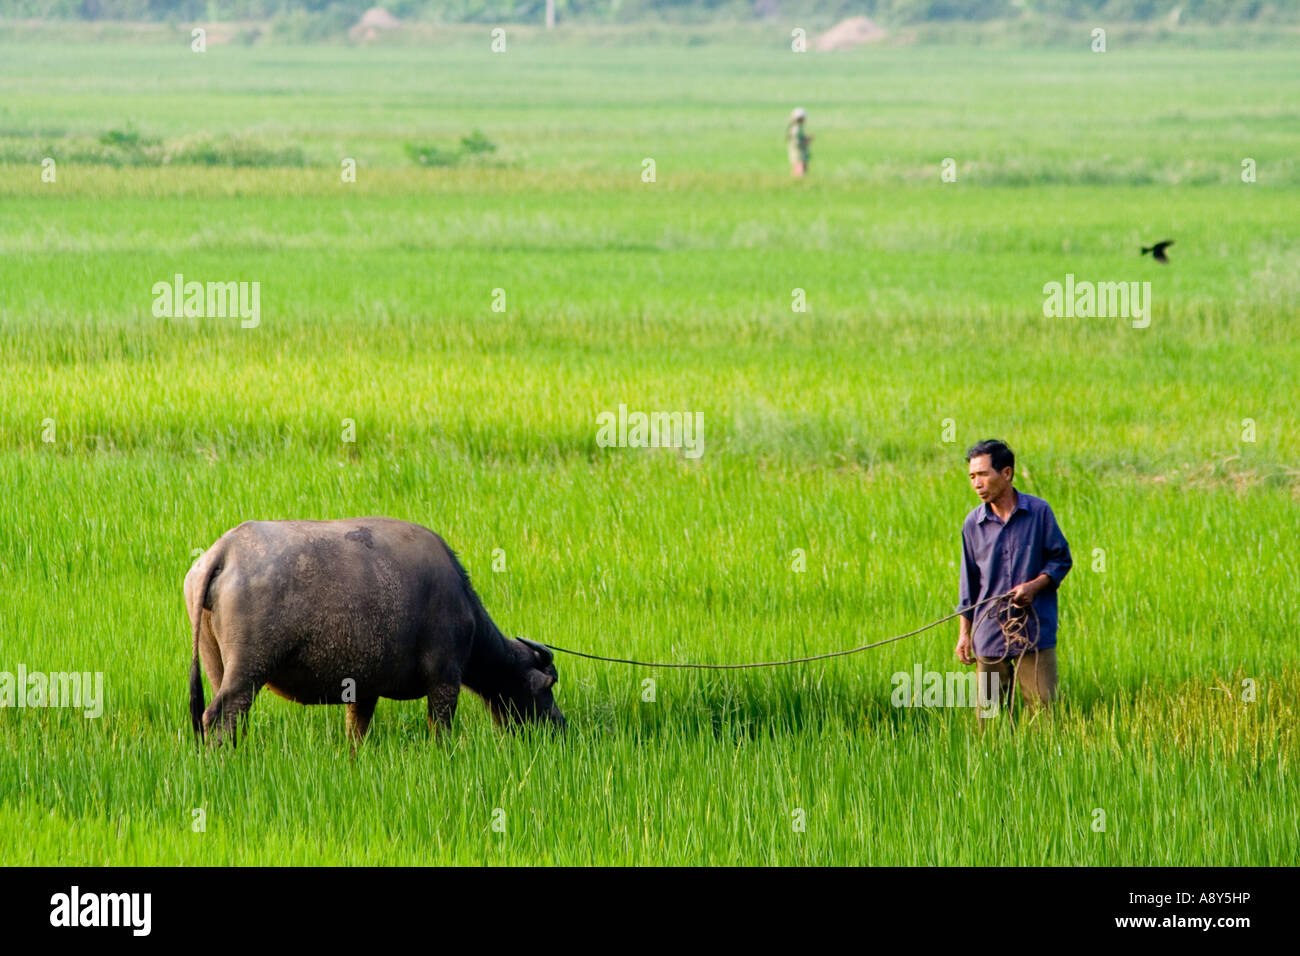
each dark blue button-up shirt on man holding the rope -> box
[961,490,1074,658]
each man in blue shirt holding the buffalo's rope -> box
[957,440,1074,727]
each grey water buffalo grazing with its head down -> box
[185,518,564,747]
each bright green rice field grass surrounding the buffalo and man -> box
[0,39,1300,865]
